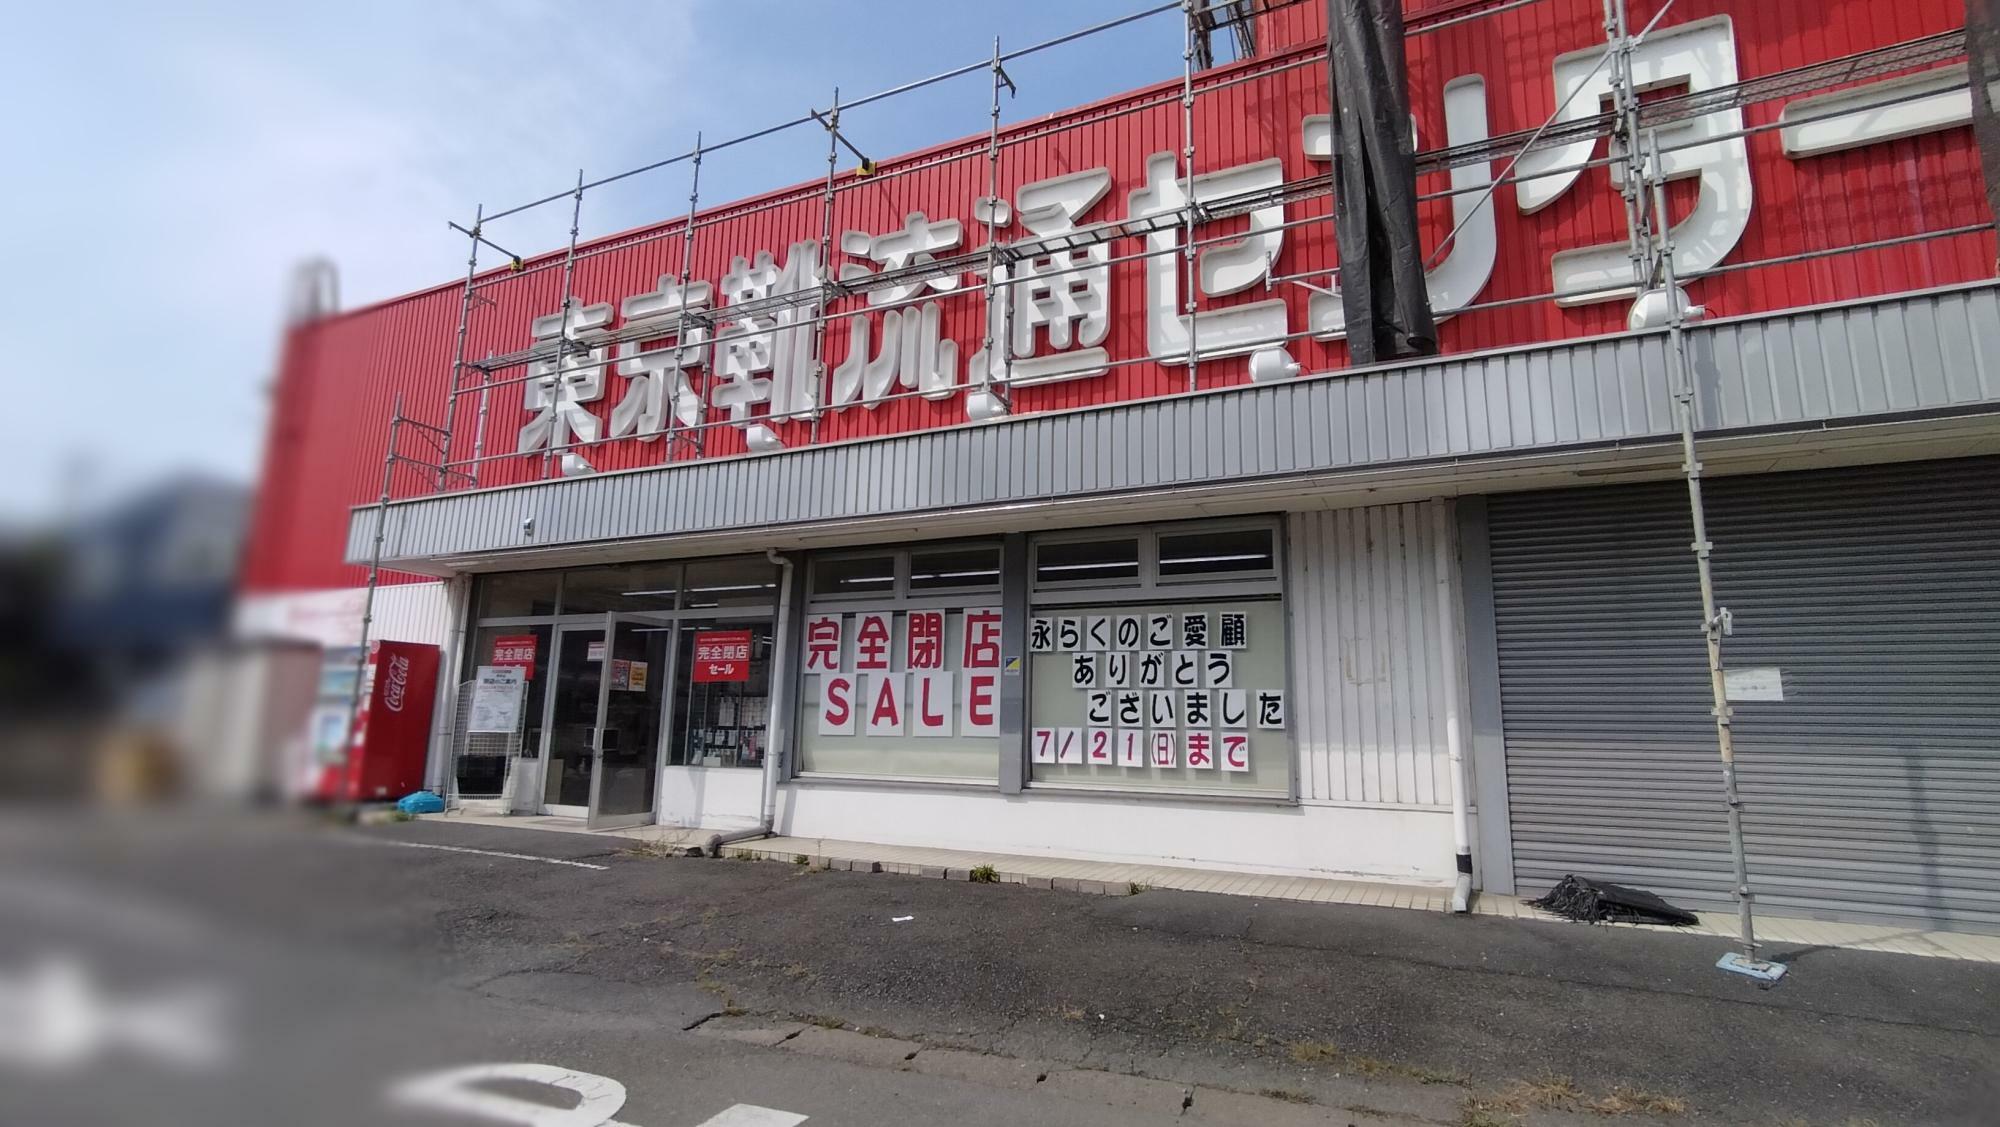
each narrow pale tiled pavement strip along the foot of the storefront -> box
[422,813,2000,963]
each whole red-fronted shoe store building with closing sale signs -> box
[240,0,2000,929]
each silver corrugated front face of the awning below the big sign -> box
[348,286,2000,562]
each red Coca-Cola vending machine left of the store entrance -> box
[316,641,438,801]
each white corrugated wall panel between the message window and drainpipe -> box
[1286,502,1462,807]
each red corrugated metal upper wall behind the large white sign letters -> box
[246,0,1994,589]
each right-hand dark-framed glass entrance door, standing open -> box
[590,613,674,829]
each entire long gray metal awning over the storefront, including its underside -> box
[346,282,2000,575]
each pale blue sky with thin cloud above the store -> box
[0,0,1184,524]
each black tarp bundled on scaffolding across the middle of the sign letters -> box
[1326,0,1438,364]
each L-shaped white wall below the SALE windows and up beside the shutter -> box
[756,502,1458,885]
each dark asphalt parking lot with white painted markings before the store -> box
[0,815,2000,1127]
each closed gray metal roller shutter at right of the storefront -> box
[1490,458,2000,931]
